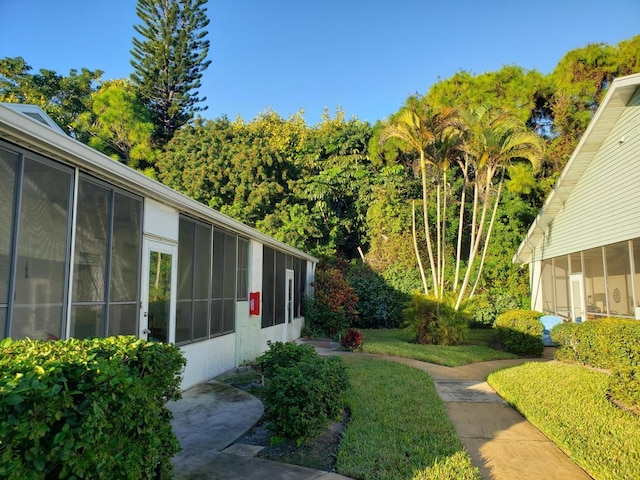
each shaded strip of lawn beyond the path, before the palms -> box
[362,329,518,367]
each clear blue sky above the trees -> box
[0,0,640,124]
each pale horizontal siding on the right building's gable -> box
[534,86,640,259]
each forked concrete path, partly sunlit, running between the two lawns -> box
[305,341,591,480]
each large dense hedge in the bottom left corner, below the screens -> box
[0,337,185,480]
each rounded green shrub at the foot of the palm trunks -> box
[404,293,469,345]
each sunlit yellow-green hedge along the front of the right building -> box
[551,318,640,410]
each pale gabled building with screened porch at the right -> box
[514,74,640,322]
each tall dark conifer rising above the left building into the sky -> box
[131,0,211,145]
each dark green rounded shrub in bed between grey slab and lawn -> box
[264,354,349,443]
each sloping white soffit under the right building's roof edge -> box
[513,74,640,264]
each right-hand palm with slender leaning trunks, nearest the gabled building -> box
[455,107,544,310]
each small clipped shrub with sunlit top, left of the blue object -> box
[495,310,544,356]
